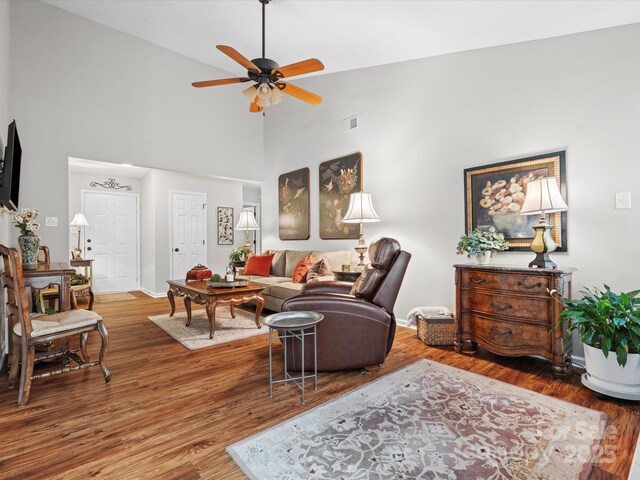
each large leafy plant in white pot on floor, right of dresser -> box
[560,285,640,400]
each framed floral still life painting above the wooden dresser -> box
[464,151,567,252]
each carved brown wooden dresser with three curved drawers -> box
[454,265,574,378]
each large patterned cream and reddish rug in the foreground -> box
[227,360,607,480]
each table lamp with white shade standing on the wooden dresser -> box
[520,177,569,268]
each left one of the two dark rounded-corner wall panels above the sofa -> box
[278,168,310,240]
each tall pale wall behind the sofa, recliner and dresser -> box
[262,25,640,326]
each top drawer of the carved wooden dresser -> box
[460,270,550,295]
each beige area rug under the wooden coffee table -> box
[149,307,269,350]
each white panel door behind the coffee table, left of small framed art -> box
[170,192,207,279]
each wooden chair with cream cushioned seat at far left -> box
[0,245,111,406]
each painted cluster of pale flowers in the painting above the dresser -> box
[480,172,544,217]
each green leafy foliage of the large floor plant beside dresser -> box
[560,285,640,367]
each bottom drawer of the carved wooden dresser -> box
[461,313,551,351]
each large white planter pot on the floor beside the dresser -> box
[582,344,640,400]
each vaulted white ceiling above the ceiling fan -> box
[45,0,640,80]
